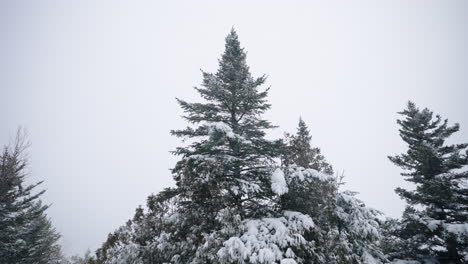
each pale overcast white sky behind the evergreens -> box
[0,0,468,254]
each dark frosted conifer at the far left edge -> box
[0,131,63,264]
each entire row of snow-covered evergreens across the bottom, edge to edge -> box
[0,30,468,264]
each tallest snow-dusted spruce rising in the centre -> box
[168,29,281,262]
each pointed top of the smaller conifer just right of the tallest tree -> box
[283,118,333,175]
